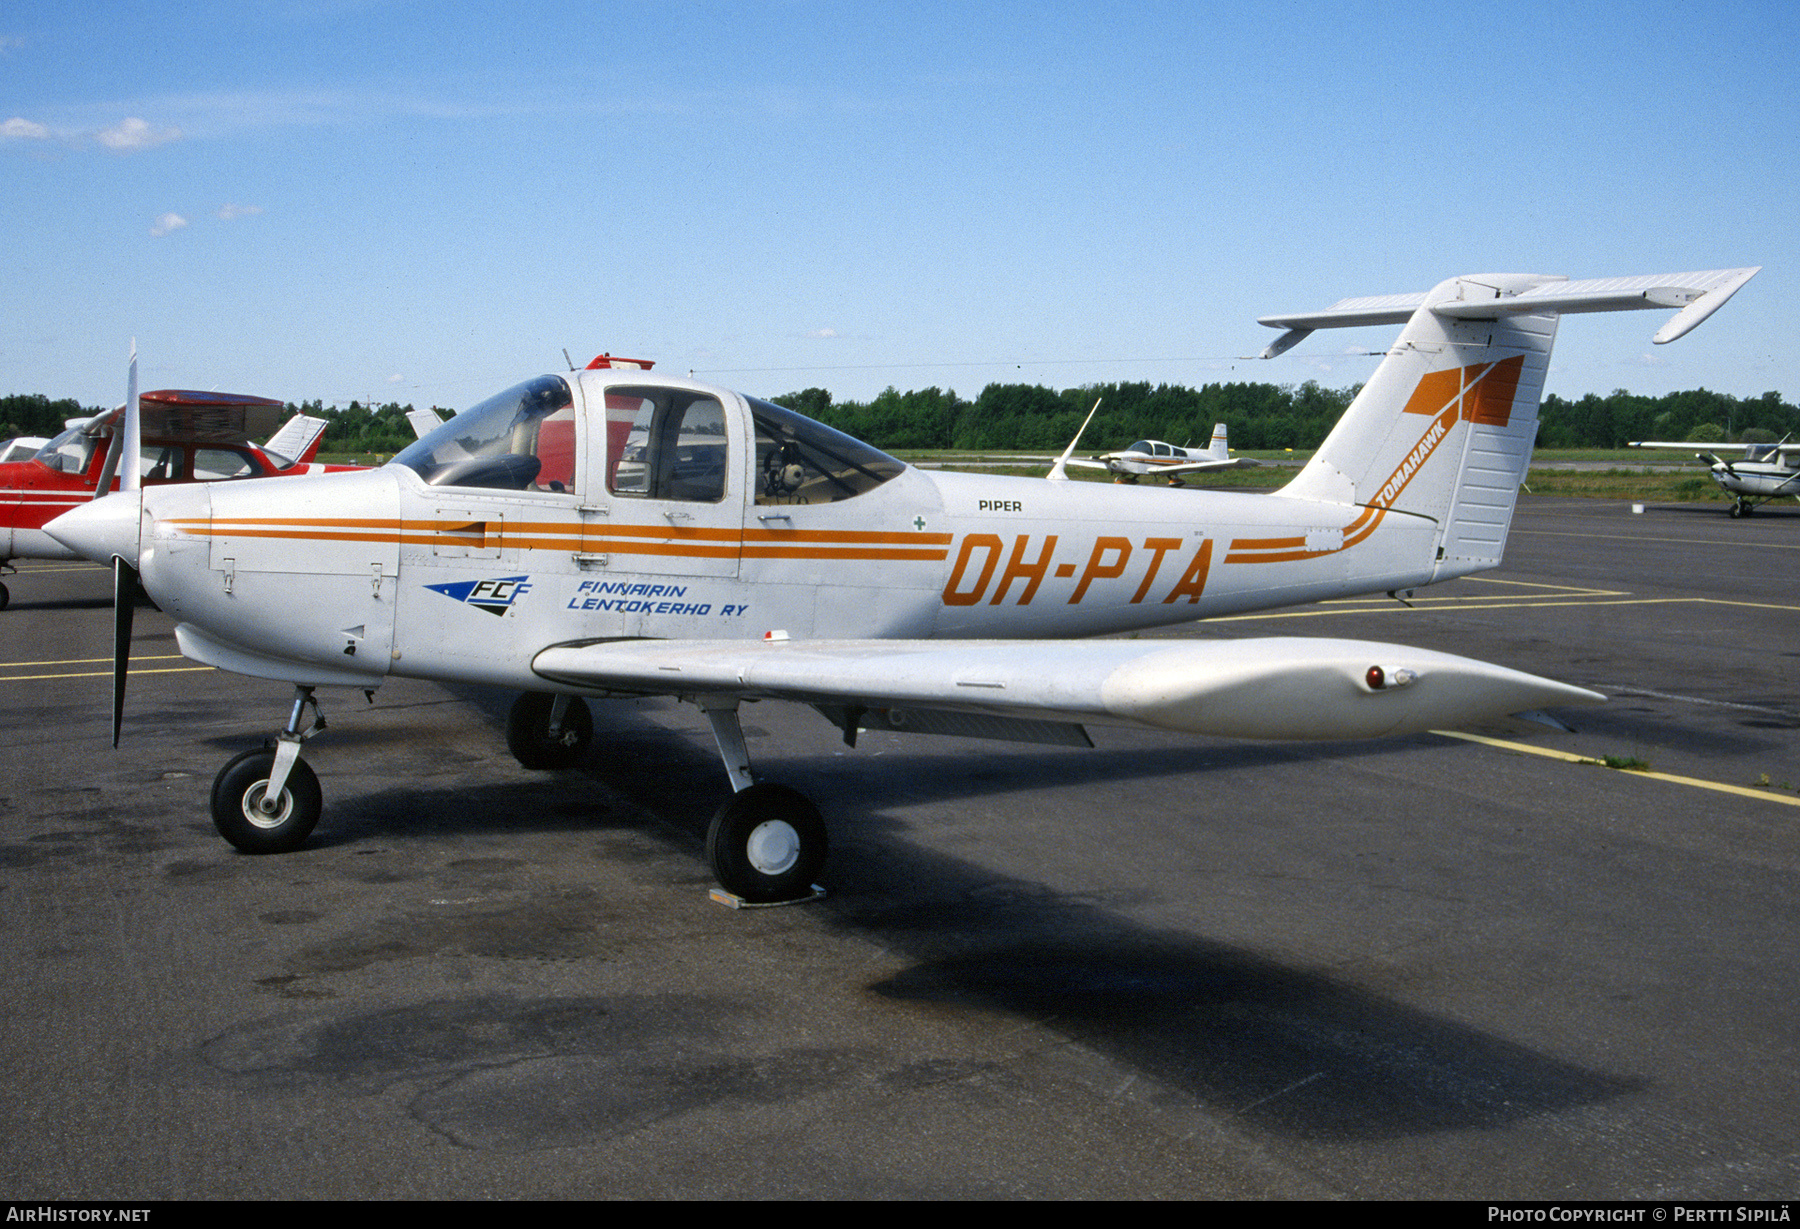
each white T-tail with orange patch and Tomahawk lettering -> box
[1262,268,1759,581]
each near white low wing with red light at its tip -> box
[533,637,1604,740]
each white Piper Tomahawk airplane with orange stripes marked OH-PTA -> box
[54,270,1755,900]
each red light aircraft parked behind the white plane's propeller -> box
[0,389,353,610]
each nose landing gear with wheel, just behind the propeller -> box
[212,686,326,853]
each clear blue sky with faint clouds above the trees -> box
[0,0,1800,415]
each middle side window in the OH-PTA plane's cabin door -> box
[607,387,729,504]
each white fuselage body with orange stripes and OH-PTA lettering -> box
[123,370,1442,687]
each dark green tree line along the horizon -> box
[0,380,1800,453]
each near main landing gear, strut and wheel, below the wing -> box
[700,698,826,907]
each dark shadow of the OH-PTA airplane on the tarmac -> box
[270,689,1643,1139]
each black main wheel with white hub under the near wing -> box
[706,785,828,902]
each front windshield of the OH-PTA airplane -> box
[391,376,574,491]
